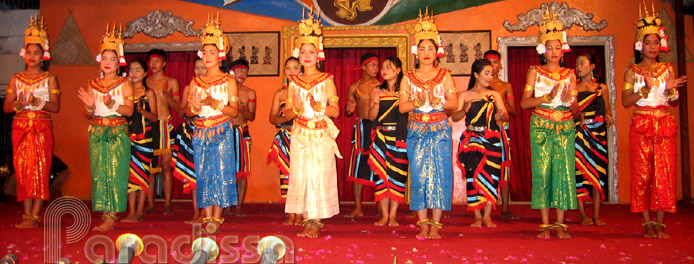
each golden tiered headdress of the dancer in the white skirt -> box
[292,6,325,61]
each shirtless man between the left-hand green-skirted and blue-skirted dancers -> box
[146,49,181,215]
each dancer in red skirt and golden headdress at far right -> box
[622,7,687,238]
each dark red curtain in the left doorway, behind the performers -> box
[125,51,198,199]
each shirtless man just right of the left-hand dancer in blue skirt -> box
[226,59,256,216]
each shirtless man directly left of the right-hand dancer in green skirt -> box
[484,50,518,219]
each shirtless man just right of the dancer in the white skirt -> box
[345,53,380,217]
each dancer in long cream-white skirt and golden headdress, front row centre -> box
[285,7,342,238]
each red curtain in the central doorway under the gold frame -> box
[323,48,397,201]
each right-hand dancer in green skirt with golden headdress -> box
[521,9,578,239]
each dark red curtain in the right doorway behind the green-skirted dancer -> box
[504,46,605,201]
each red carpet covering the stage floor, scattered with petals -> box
[0,201,694,263]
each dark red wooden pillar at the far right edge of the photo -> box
[674,0,692,200]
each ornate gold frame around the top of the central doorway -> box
[282,25,413,69]
